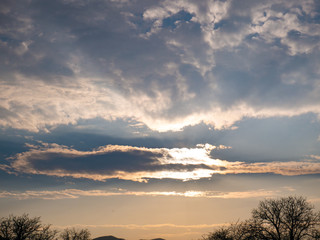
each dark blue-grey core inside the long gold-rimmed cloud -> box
[28,150,210,175]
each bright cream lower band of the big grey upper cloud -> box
[0,76,320,132]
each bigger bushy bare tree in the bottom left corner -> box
[0,214,57,240]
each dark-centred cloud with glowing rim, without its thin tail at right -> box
[3,143,226,181]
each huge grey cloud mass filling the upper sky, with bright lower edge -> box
[0,0,320,132]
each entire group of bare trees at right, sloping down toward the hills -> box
[203,196,320,240]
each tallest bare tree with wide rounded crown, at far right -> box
[252,196,320,240]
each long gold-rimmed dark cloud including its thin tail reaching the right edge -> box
[1,143,320,181]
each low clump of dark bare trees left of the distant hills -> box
[0,214,91,240]
